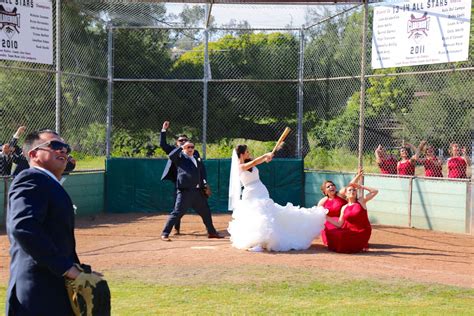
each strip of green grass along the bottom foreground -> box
[0,267,474,316]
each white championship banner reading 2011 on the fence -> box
[372,0,471,69]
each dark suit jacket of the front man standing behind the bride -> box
[169,147,207,189]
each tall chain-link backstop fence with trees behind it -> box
[0,0,474,176]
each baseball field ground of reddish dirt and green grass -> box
[0,213,474,315]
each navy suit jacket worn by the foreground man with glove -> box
[6,168,79,315]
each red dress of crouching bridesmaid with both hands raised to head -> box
[326,202,372,253]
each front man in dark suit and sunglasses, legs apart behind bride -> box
[161,141,223,241]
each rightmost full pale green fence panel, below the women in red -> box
[411,179,468,233]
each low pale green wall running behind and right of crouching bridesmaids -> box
[305,171,471,233]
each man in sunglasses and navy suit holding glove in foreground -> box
[6,130,110,316]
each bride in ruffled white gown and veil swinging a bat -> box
[227,145,326,251]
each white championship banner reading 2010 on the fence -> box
[0,0,53,65]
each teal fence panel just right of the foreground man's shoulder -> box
[63,171,105,216]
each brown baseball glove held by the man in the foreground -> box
[66,264,110,316]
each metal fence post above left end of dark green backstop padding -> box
[105,24,114,158]
